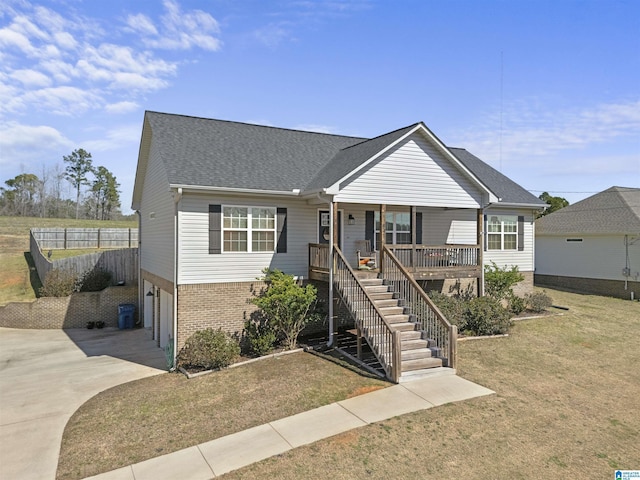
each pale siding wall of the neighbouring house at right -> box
[536,235,640,280]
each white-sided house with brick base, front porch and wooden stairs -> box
[132,112,545,380]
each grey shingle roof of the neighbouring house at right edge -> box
[536,187,640,235]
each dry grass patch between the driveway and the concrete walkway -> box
[57,352,389,480]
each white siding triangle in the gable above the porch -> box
[335,133,482,208]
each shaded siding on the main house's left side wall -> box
[140,140,175,282]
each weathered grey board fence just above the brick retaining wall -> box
[29,229,138,285]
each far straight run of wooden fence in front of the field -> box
[31,228,138,250]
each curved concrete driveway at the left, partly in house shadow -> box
[0,328,166,480]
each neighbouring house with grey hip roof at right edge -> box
[535,187,640,298]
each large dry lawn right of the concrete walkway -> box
[223,289,640,480]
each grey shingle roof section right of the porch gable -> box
[449,147,546,207]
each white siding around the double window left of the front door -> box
[178,194,318,285]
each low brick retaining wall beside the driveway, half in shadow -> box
[0,286,138,329]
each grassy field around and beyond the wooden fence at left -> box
[0,216,138,305]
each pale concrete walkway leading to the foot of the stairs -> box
[87,374,494,480]
